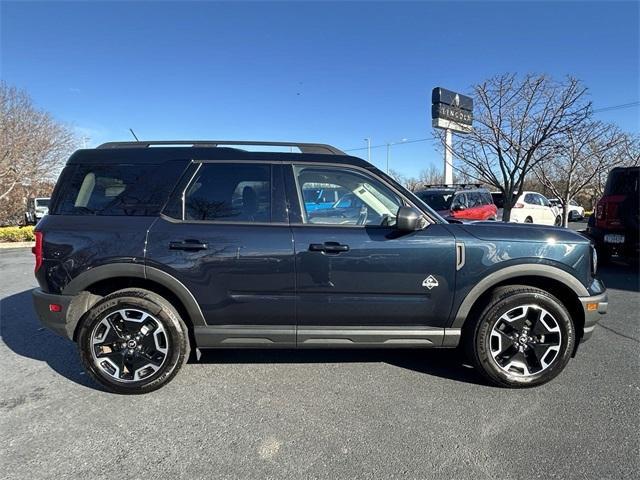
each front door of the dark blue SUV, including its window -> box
[288,165,456,346]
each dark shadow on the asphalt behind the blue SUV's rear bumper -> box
[0,290,102,390]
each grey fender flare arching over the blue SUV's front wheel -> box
[451,264,590,328]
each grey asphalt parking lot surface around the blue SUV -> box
[0,249,640,479]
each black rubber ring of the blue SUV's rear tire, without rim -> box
[78,292,188,393]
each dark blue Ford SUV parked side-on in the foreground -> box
[33,141,607,393]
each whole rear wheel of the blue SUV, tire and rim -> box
[78,288,190,394]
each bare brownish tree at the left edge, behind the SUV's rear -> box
[0,82,77,223]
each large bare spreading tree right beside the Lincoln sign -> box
[444,74,591,221]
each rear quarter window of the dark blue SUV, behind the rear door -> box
[52,160,187,216]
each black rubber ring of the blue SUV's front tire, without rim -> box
[475,292,576,387]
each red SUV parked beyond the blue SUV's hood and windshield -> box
[416,184,498,220]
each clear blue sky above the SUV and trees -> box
[0,1,640,175]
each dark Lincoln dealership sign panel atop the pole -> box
[431,87,473,133]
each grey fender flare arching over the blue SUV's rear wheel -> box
[62,263,207,326]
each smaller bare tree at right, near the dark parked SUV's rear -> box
[533,122,624,227]
